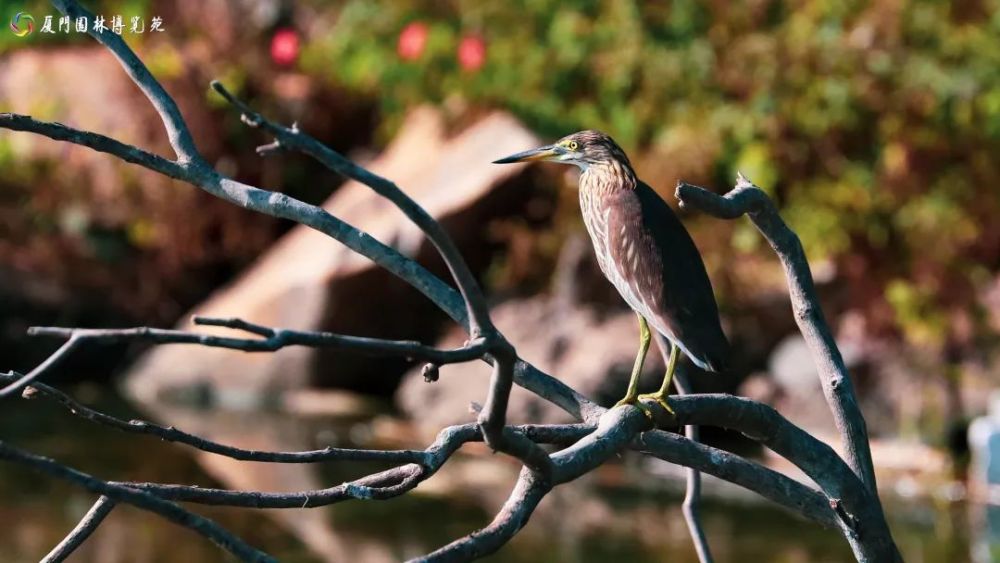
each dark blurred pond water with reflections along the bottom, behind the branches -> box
[0,388,989,563]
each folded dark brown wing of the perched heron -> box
[607,182,729,371]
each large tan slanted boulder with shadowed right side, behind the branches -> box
[127,109,538,408]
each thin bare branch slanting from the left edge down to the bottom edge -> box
[0,441,276,563]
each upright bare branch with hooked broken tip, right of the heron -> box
[677,174,879,503]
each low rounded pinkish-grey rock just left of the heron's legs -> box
[396,296,663,433]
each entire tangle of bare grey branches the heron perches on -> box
[0,0,899,561]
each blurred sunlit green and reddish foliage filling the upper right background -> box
[303,0,1000,352]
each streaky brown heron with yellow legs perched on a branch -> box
[494,130,730,416]
